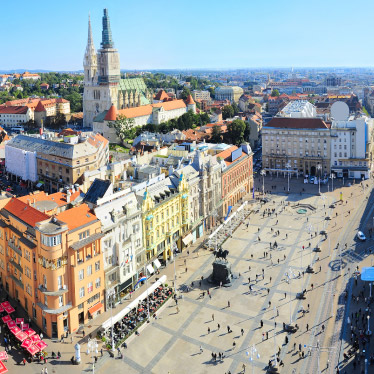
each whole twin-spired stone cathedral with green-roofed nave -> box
[83,9,153,127]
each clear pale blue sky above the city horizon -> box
[0,0,374,70]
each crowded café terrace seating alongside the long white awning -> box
[101,286,173,346]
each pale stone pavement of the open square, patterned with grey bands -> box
[3,177,374,374]
